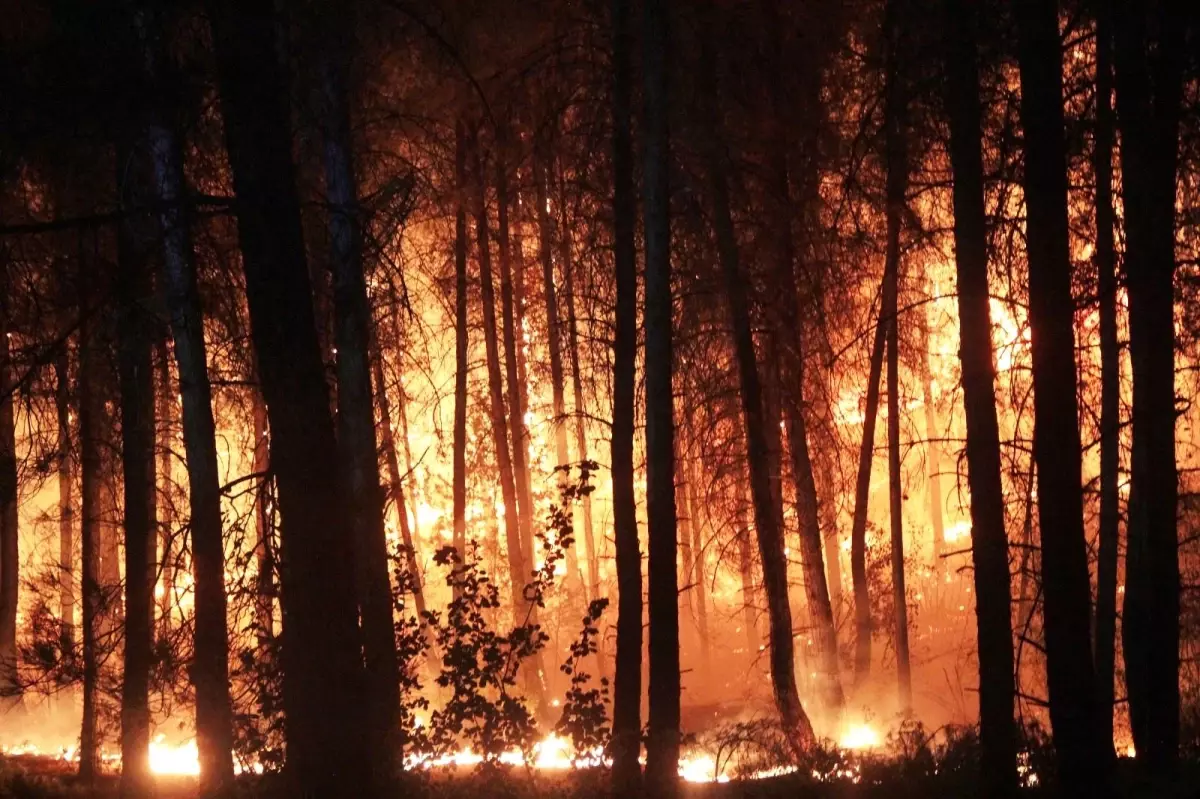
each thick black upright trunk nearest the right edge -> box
[1114,1,1187,779]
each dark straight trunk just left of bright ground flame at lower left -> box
[116,145,156,797]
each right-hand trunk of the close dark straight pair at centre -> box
[643,0,681,797]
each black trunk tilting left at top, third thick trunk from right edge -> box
[944,0,1016,799]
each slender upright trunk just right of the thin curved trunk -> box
[880,0,912,711]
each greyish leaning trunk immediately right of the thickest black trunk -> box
[318,17,400,785]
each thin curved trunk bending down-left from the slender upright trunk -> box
[850,289,887,685]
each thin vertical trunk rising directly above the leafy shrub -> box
[451,119,470,590]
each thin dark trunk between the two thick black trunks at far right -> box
[1092,0,1121,758]
